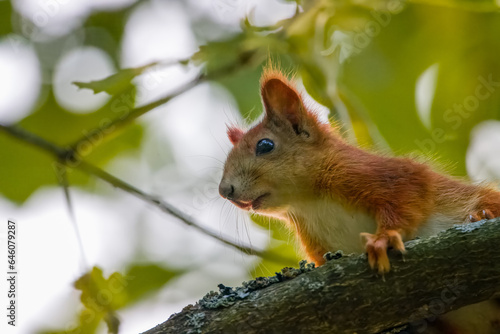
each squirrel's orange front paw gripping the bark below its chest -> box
[360,230,405,274]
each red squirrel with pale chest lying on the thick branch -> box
[219,69,500,274]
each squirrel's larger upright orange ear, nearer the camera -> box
[261,78,305,134]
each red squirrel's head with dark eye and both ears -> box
[219,70,331,215]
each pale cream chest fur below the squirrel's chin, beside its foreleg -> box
[288,199,377,253]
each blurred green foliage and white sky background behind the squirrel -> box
[0,0,500,333]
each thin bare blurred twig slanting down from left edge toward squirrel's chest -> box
[0,124,293,263]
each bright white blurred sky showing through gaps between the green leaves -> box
[0,0,500,334]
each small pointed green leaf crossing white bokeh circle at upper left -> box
[73,62,158,95]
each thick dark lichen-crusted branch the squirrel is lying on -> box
[144,218,500,334]
